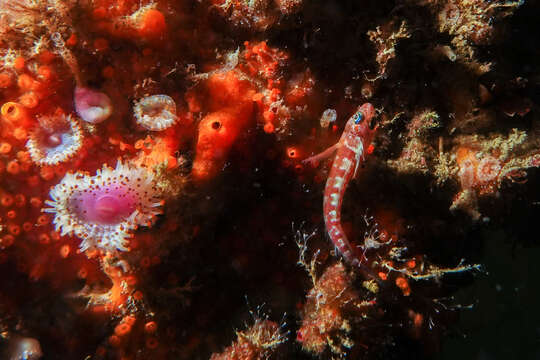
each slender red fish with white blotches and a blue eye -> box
[304,103,376,266]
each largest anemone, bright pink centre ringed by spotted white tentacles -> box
[43,161,162,252]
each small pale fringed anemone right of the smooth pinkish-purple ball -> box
[133,95,178,131]
